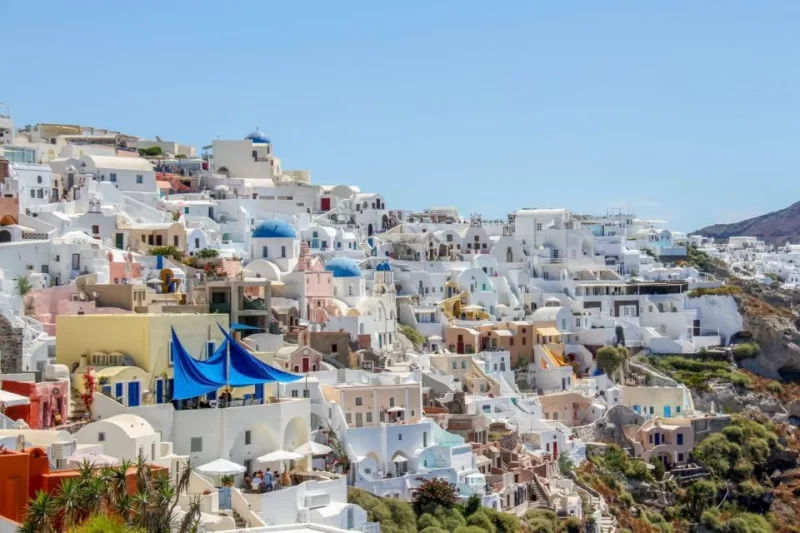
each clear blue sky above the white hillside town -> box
[0,0,800,230]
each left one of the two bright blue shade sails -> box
[172,329,225,400]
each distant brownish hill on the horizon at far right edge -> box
[692,202,800,245]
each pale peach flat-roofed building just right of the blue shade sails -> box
[322,383,422,427]
